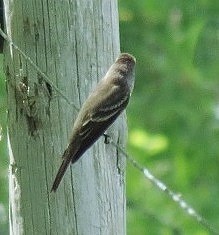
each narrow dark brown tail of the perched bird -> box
[51,149,71,192]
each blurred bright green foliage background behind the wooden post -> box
[0,0,219,235]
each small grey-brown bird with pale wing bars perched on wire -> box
[51,53,136,192]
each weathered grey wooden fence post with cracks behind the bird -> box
[5,0,126,235]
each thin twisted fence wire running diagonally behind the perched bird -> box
[0,28,219,235]
